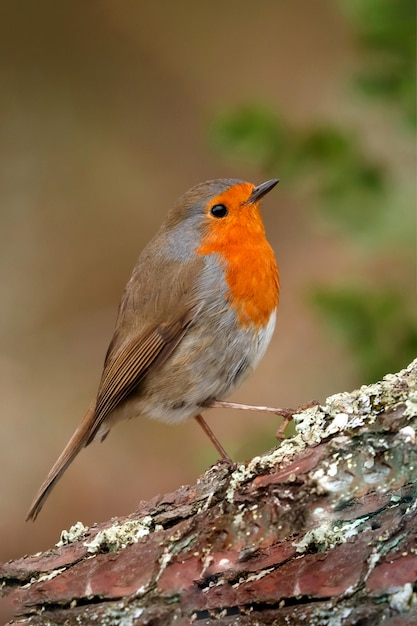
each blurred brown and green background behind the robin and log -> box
[0,0,417,616]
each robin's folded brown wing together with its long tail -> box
[26,255,201,520]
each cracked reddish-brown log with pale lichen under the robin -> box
[0,360,417,626]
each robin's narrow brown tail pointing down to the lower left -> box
[26,402,96,522]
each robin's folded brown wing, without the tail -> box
[85,251,203,438]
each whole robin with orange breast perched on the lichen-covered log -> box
[26,178,283,520]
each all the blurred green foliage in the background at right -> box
[210,0,417,383]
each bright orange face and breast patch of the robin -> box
[197,185,279,327]
